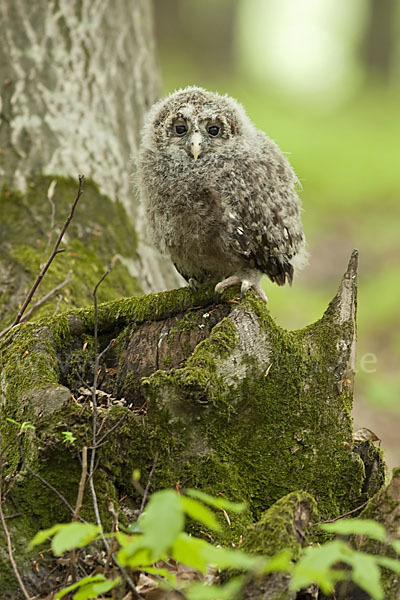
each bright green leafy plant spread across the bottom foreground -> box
[31,489,400,600]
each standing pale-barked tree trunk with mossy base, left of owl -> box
[0,0,178,322]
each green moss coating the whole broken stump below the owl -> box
[0,276,386,592]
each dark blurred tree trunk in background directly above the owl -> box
[154,0,239,78]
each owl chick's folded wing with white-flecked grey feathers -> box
[220,134,304,285]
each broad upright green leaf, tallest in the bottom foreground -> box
[139,490,185,556]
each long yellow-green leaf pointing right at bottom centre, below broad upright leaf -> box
[172,533,266,573]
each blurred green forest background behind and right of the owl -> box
[154,0,400,466]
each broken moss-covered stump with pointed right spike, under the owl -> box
[0,253,384,598]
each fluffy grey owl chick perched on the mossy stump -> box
[137,87,306,302]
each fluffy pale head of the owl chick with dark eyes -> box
[142,87,255,161]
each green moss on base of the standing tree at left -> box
[0,176,141,329]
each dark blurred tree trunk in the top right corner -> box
[361,0,398,84]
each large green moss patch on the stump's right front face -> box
[144,295,372,518]
